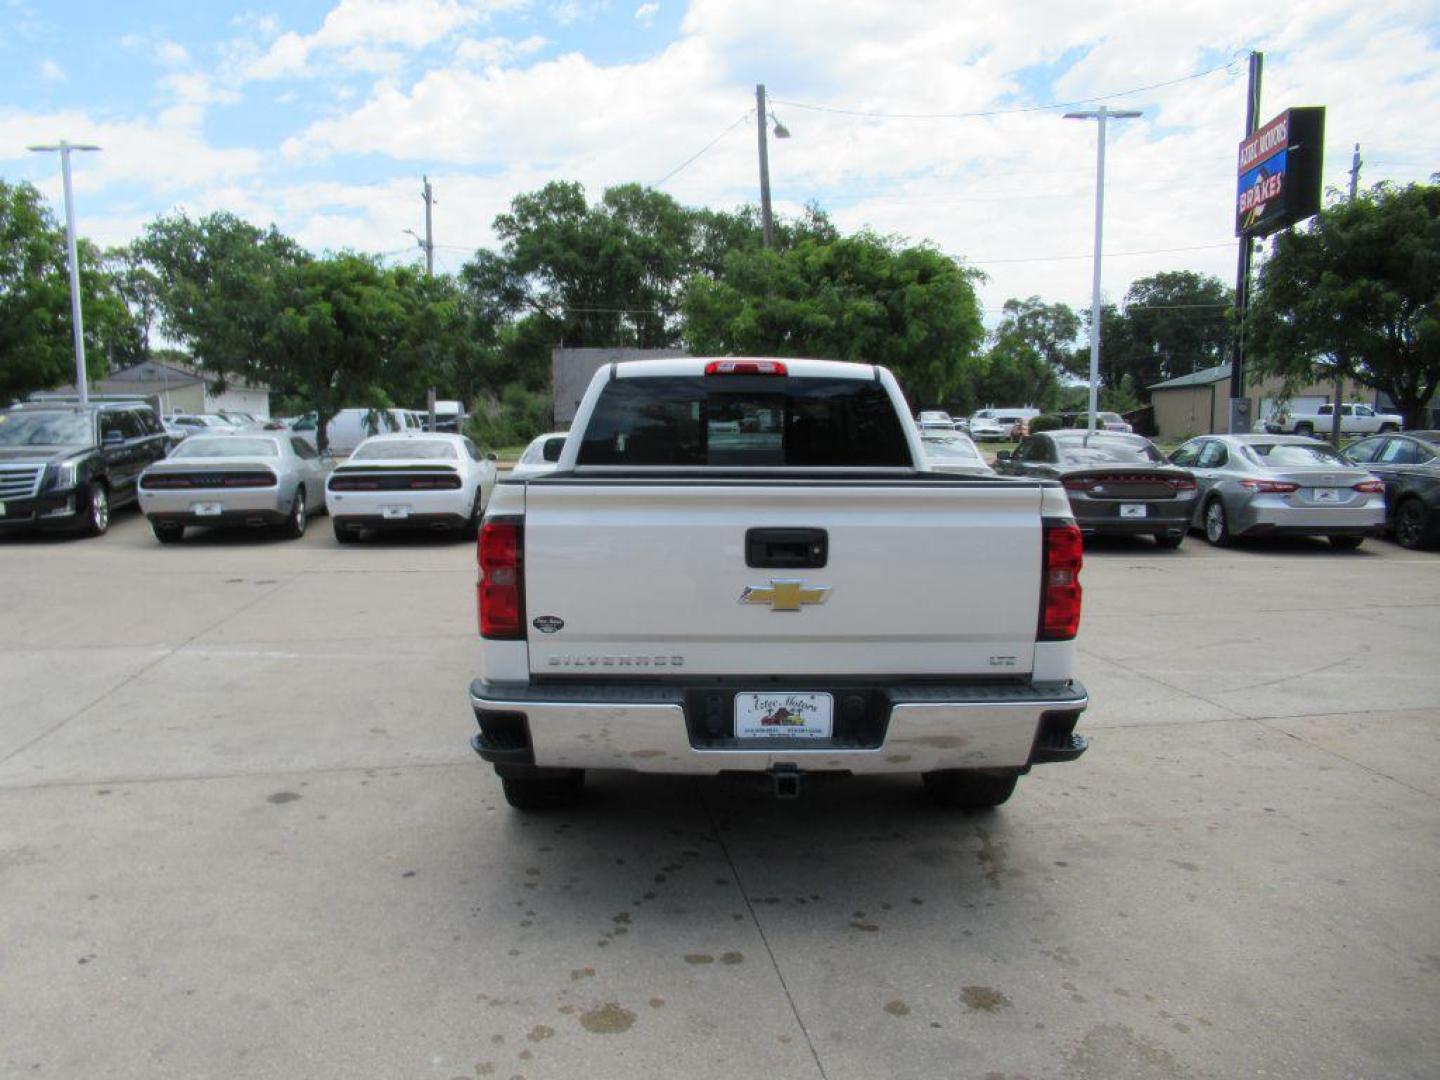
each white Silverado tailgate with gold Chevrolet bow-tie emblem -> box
[524,477,1043,678]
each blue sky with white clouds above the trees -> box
[0,0,1440,321]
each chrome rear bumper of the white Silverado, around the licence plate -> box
[469,680,1089,775]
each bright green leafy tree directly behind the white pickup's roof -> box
[684,232,984,406]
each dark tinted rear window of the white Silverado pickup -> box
[576,376,913,468]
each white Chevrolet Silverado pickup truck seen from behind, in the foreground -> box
[469,359,1087,809]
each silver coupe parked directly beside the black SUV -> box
[140,432,331,544]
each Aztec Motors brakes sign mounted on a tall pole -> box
[1236,107,1325,236]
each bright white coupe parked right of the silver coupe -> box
[325,433,495,544]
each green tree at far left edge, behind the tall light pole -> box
[0,180,138,402]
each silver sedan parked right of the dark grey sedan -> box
[1169,433,1385,550]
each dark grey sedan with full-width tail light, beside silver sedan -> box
[995,429,1195,547]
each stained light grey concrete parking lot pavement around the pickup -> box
[0,514,1440,1080]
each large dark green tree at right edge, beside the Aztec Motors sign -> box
[1246,184,1440,426]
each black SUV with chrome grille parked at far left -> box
[0,402,170,536]
